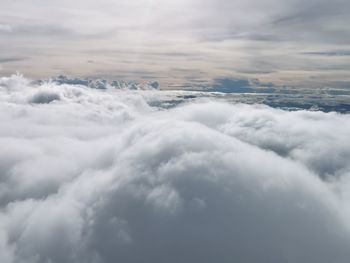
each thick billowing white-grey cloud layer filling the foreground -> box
[0,76,350,263]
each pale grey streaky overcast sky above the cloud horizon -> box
[0,0,350,87]
